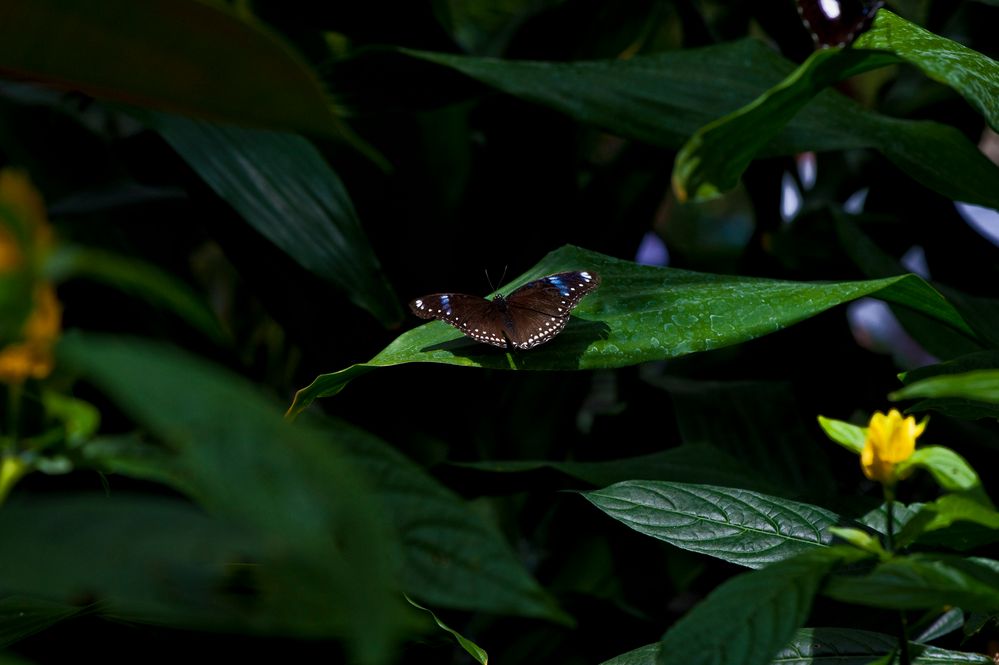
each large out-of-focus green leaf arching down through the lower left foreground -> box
[59,333,403,662]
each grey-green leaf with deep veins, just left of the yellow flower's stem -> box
[583,480,839,568]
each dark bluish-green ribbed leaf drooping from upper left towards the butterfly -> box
[138,113,402,326]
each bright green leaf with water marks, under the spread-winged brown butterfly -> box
[288,245,971,416]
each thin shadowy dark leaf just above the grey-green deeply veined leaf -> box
[453,444,774,491]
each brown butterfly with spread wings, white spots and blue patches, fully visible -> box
[409,270,600,349]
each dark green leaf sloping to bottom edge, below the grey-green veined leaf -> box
[659,547,866,665]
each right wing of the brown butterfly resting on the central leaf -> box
[504,270,600,349]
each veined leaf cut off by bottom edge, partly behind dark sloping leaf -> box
[602,628,994,665]
